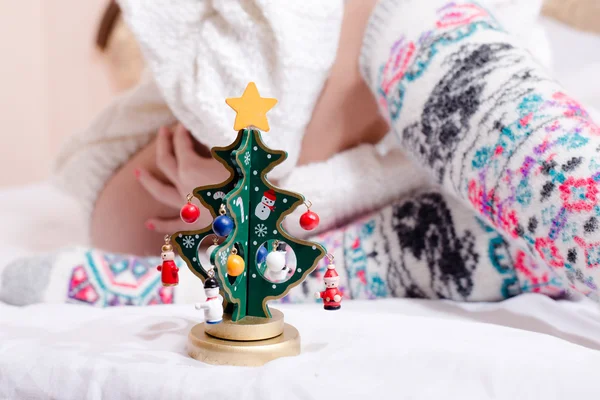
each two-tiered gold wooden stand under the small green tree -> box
[187,309,300,366]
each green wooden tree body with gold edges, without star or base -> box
[172,129,326,322]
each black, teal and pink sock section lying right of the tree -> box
[281,190,566,303]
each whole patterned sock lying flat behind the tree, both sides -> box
[0,190,565,307]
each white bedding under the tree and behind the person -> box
[0,17,600,400]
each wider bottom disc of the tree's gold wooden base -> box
[187,323,300,367]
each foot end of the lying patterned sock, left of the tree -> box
[0,248,203,307]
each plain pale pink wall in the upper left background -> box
[0,0,115,187]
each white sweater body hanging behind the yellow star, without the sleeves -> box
[120,0,343,179]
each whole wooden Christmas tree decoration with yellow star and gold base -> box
[172,83,326,366]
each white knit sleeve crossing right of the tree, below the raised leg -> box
[281,144,431,236]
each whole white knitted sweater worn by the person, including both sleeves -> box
[51,0,547,235]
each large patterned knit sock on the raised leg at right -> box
[361,0,600,299]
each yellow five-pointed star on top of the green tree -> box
[225,82,277,132]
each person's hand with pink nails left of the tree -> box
[135,124,227,233]
